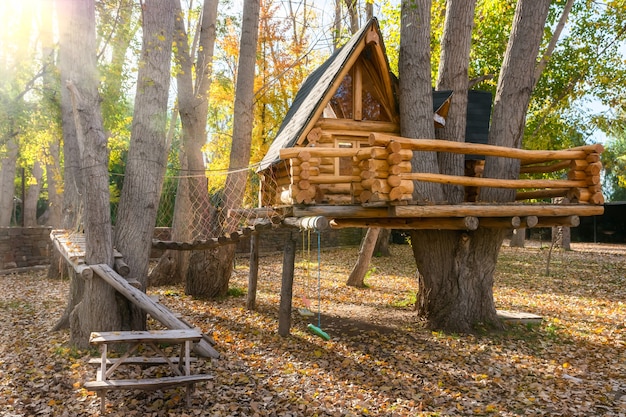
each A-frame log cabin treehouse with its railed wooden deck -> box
[259,19,604,230]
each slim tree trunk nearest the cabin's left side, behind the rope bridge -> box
[186,0,260,298]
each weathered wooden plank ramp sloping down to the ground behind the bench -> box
[90,264,220,358]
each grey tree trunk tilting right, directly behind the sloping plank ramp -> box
[115,0,176,330]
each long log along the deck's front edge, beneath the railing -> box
[392,203,604,217]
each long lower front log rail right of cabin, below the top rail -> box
[399,173,587,189]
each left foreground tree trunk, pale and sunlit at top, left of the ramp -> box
[61,0,121,348]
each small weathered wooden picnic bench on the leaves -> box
[84,329,213,414]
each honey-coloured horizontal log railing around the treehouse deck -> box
[280,133,604,205]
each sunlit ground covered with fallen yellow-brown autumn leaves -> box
[0,245,626,416]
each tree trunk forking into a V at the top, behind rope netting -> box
[150,0,218,285]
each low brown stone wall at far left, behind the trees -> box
[0,227,52,269]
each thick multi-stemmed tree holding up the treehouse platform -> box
[399,0,550,332]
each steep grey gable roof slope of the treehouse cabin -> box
[258,18,389,171]
